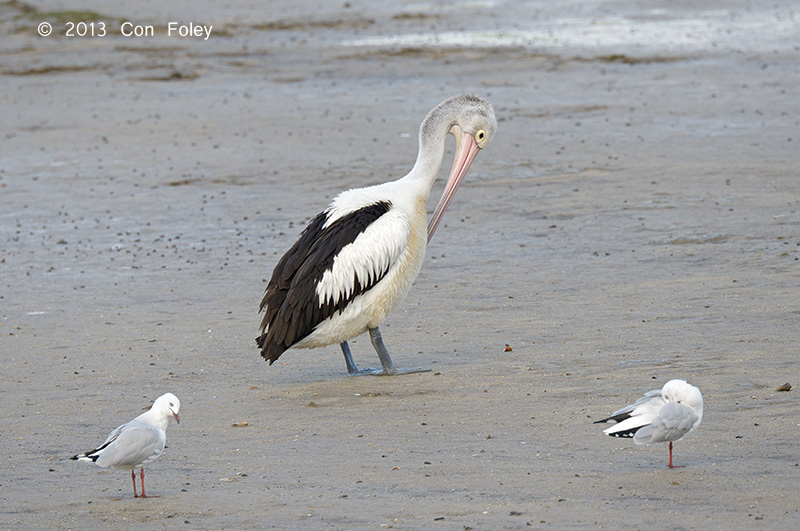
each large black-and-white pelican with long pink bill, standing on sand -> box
[256,94,497,376]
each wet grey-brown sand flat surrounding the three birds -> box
[0,1,800,530]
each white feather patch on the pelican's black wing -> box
[316,210,411,306]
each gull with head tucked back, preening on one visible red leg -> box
[595,380,703,468]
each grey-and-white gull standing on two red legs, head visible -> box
[71,393,181,498]
